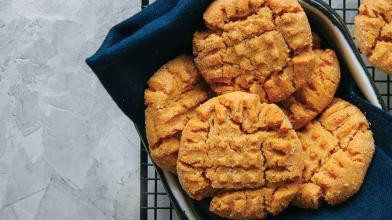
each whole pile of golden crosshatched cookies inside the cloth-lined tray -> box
[145,0,374,219]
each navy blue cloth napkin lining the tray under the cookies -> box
[87,0,392,220]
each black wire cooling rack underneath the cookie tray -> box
[140,0,392,220]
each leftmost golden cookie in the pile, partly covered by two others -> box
[144,55,209,173]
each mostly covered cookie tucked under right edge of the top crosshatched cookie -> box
[281,49,340,129]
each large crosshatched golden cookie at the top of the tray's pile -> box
[193,0,314,103]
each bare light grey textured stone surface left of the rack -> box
[0,0,140,220]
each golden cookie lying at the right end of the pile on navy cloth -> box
[293,99,375,209]
